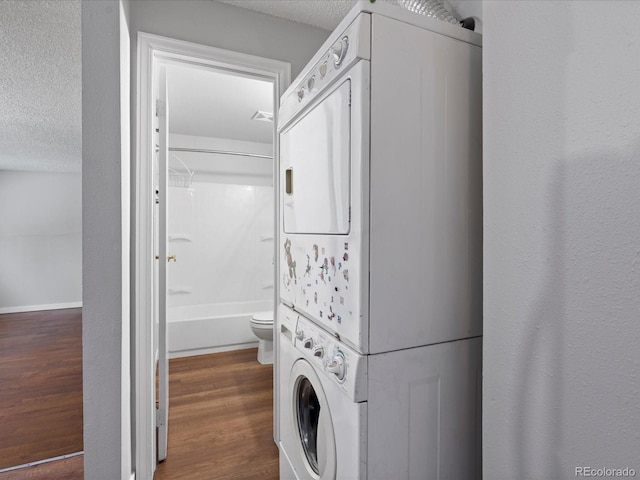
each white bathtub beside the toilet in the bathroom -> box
[167,300,273,358]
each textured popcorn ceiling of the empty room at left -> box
[0,0,82,172]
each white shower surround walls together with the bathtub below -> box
[167,175,274,357]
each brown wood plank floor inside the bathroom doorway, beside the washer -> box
[154,349,279,480]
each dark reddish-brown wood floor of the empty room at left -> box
[0,308,83,470]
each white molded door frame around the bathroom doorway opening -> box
[131,32,291,480]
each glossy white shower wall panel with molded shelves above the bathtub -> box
[168,182,273,307]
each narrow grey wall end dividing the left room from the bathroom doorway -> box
[82,0,132,480]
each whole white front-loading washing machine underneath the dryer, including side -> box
[277,306,482,480]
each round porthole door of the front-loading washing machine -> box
[290,359,336,480]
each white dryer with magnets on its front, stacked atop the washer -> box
[278,1,482,354]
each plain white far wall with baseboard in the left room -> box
[0,171,82,313]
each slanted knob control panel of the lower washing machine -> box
[294,315,367,402]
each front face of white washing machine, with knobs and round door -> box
[278,307,367,479]
